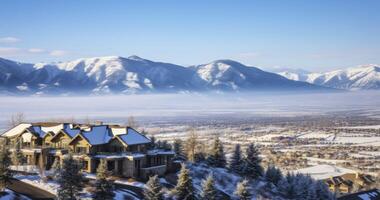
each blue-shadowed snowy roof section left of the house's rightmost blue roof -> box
[82,125,113,145]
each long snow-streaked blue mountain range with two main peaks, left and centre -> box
[0,56,323,94]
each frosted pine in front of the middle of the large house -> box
[94,160,115,200]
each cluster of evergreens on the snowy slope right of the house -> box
[144,131,335,200]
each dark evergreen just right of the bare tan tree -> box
[207,137,226,168]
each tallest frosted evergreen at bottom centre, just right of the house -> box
[173,164,195,200]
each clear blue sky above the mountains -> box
[0,0,380,71]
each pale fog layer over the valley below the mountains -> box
[0,91,380,130]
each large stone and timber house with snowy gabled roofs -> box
[1,123,174,178]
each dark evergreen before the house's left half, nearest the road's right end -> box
[57,154,83,200]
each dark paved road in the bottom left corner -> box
[8,179,56,200]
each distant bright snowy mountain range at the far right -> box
[277,64,380,90]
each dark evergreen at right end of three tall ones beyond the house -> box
[242,144,263,179]
